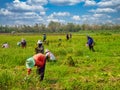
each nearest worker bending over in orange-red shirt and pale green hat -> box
[26,53,46,81]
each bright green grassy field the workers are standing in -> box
[0,33,120,90]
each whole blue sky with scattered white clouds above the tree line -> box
[0,0,120,25]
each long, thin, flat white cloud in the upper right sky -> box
[90,8,117,13]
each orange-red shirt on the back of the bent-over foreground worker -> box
[33,53,46,67]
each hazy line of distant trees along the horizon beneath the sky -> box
[0,21,120,33]
